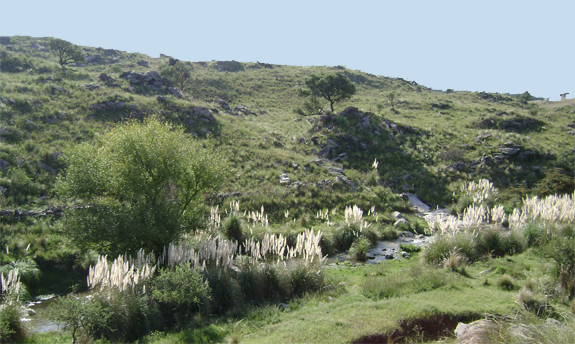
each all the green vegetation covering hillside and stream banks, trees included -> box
[0,37,575,343]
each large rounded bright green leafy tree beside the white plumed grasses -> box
[56,119,226,254]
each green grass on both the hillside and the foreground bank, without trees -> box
[0,36,575,343]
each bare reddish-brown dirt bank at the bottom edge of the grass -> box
[353,314,481,344]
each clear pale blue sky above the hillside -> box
[0,0,575,100]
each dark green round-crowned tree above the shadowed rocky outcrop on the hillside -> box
[304,73,356,111]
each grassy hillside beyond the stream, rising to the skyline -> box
[0,37,575,213]
